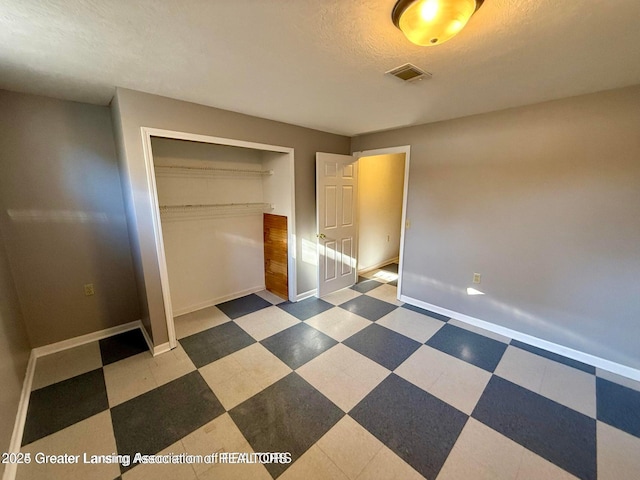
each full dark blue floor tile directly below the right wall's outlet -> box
[426,324,507,372]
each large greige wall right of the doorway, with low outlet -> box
[352,86,640,368]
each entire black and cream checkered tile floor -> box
[18,266,640,480]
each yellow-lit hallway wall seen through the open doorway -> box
[358,153,404,270]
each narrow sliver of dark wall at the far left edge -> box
[0,236,31,476]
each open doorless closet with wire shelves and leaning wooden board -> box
[143,129,296,348]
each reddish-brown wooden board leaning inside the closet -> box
[263,213,289,300]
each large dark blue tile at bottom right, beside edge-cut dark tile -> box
[472,375,596,480]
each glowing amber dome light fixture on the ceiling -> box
[391,0,484,47]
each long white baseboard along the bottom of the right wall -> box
[400,295,640,381]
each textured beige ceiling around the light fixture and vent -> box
[0,0,640,135]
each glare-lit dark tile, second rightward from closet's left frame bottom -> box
[260,323,338,370]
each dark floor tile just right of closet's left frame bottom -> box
[180,322,256,368]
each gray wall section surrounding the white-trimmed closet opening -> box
[112,88,350,345]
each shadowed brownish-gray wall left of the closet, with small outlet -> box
[0,91,140,347]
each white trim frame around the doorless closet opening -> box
[140,127,297,348]
